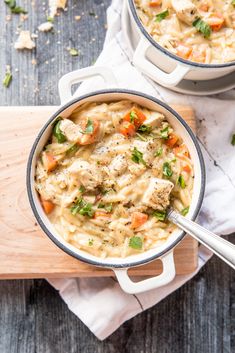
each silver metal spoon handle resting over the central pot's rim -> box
[168,210,235,269]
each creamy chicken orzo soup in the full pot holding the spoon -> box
[35,101,194,257]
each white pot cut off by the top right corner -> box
[127,0,235,87]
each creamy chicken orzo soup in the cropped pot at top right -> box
[135,0,235,64]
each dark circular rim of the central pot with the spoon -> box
[26,89,206,268]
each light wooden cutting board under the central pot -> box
[0,106,198,279]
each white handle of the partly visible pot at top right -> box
[133,38,190,87]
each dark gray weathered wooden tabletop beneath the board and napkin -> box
[0,0,235,353]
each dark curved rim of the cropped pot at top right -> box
[128,0,235,68]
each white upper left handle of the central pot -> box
[58,66,118,104]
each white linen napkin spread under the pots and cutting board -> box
[49,0,235,340]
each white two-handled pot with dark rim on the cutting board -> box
[27,67,205,293]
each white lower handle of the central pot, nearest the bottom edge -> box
[113,251,175,294]
